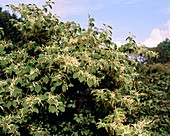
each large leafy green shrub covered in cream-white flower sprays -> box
[0,1,170,136]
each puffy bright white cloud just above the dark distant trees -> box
[143,20,170,47]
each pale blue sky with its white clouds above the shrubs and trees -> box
[0,0,170,47]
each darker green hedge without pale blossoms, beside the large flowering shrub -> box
[138,63,170,136]
